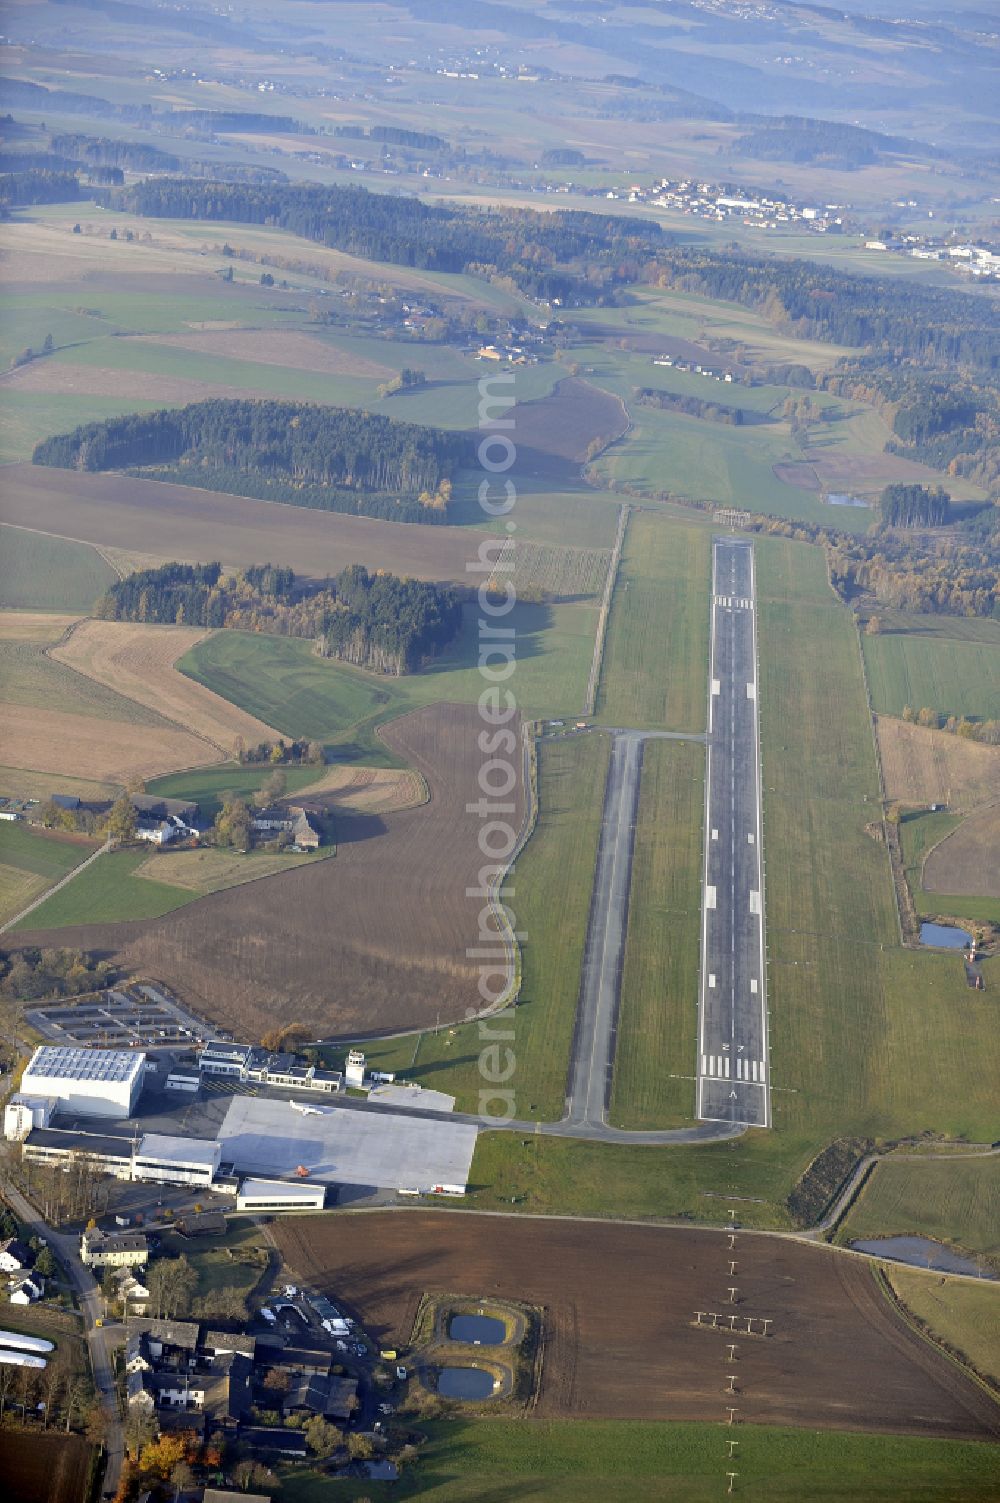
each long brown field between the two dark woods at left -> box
[0,464,483,585]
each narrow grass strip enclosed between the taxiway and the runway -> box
[611,741,705,1129]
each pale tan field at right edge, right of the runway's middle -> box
[877,715,1000,813]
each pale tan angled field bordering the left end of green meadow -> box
[51,621,278,761]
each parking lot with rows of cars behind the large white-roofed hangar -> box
[27,983,212,1049]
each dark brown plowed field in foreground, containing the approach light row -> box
[274,1208,1000,1437]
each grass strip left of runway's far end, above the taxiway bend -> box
[597,511,711,732]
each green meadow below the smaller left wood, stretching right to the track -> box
[179,600,597,764]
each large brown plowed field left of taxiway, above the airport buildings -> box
[18,705,522,1039]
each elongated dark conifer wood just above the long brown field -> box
[32,400,468,522]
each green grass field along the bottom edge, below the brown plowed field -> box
[281,1419,995,1503]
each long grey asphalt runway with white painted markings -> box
[698,538,771,1127]
